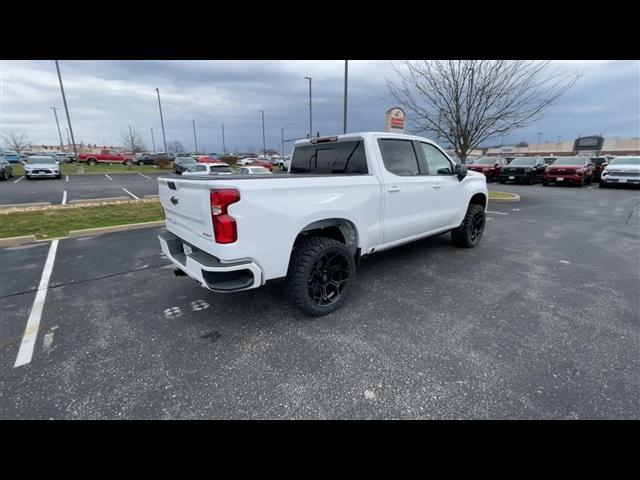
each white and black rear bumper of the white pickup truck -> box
[158,232,262,293]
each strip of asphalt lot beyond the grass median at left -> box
[0,172,165,205]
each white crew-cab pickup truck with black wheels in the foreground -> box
[158,132,488,316]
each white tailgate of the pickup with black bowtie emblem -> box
[158,178,213,248]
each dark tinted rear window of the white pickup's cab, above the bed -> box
[290,140,368,173]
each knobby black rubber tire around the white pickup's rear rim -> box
[287,237,356,317]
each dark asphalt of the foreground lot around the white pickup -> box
[0,180,640,419]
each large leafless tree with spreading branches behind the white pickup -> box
[387,60,583,163]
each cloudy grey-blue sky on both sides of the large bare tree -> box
[0,60,640,152]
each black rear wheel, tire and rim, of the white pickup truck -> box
[287,237,356,317]
